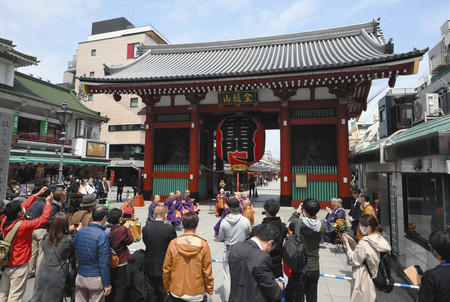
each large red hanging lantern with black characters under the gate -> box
[216,115,266,165]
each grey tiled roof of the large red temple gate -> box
[80,19,426,82]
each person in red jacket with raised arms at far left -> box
[0,187,53,302]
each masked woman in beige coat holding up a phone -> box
[341,214,391,302]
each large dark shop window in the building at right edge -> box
[403,175,450,247]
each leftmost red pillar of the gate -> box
[143,112,155,200]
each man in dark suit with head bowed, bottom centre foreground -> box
[228,224,283,302]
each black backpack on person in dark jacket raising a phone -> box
[282,219,307,273]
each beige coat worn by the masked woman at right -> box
[347,233,391,302]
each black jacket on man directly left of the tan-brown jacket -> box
[142,220,177,277]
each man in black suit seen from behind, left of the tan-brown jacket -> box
[142,206,177,302]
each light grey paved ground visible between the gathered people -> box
[24,182,414,302]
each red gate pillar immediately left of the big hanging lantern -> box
[189,105,200,201]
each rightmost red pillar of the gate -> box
[336,103,351,201]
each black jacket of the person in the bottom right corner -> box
[417,264,450,302]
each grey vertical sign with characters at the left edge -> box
[0,111,13,200]
